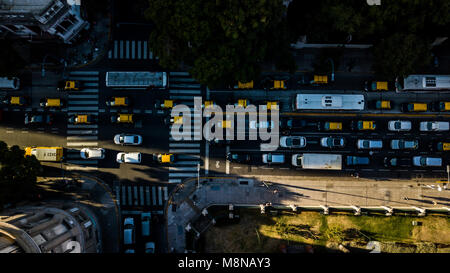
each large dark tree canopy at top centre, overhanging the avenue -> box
[146,0,295,87]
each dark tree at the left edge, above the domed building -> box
[0,141,42,209]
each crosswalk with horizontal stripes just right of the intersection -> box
[164,72,202,183]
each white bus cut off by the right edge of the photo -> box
[402,75,450,91]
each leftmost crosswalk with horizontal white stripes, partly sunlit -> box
[66,71,99,171]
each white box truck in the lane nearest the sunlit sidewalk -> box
[292,154,342,170]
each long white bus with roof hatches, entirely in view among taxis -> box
[295,94,365,110]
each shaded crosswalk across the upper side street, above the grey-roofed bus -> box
[108,40,158,60]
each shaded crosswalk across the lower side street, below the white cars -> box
[115,183,169,210]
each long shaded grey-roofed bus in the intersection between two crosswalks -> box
[106,71,169,89]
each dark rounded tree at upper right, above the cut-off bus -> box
[374,34,432,79]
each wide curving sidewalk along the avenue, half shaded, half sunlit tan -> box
[165,176,450,253]
